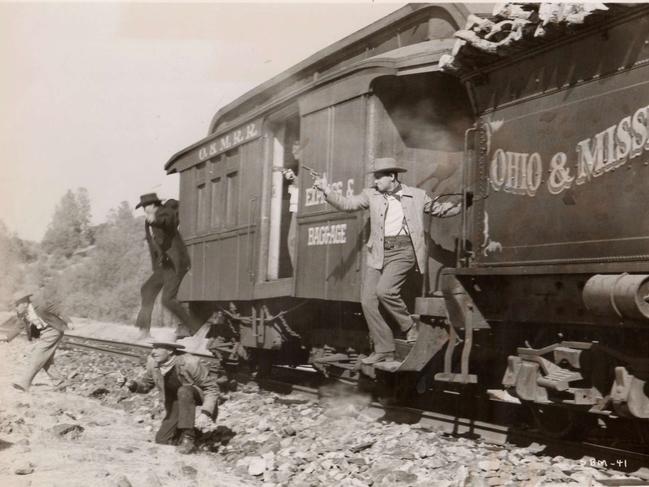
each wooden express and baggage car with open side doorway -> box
[165,4,473,369]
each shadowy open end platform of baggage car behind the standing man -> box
[372,71,473,292]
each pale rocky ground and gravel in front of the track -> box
[0,322,642,487]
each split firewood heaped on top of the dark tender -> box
[440,3,648,75]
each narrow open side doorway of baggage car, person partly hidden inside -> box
[266,109,300,281]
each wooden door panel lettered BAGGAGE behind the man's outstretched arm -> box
[296,79,367,301]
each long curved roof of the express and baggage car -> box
[165,3,478,173]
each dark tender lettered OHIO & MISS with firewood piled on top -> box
[438,5,649,430]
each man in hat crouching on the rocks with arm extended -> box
[120,330,219,454]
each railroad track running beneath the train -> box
[62,334,649,474]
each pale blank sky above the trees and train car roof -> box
[0,1,492,240]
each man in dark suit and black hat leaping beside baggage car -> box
[135,193,200,339]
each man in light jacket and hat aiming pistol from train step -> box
[314,157,461,364]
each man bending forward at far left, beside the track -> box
[0,293,68,392]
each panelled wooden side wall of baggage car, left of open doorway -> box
[179,138,264,301]
